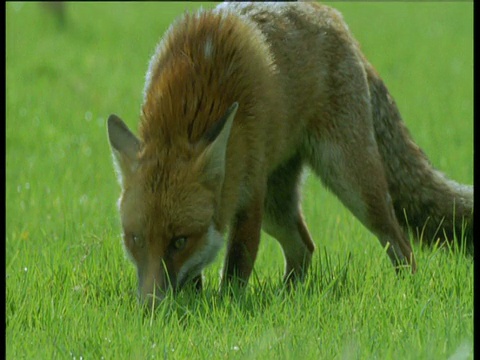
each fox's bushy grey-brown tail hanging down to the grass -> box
[367,65,473,249]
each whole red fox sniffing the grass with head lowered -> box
[108,3,473,304]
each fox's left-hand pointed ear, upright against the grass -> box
[107,115,141,186]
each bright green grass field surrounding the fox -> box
[5,2,473,360]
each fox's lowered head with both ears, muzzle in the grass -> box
[107,103,238,304]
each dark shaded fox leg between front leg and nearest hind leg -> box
[262,154,315,283]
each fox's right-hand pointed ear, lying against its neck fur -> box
[202,102,238,186]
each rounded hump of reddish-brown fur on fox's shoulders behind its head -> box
[140,10,274,148]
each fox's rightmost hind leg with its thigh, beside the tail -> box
[301,48,415,271]
